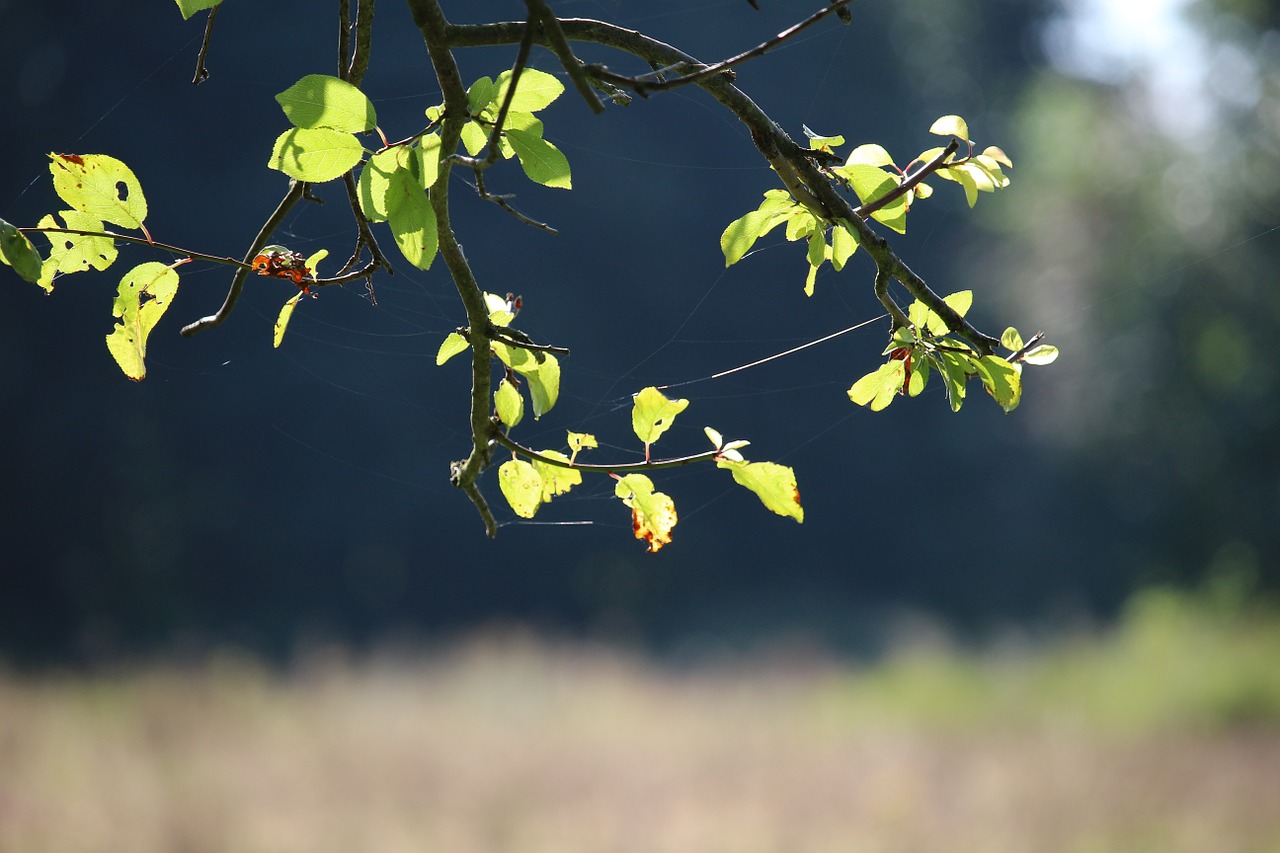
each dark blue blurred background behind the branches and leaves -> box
[0,0,1280,663]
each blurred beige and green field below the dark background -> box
[0,592,1280,853]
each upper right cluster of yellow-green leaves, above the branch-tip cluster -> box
[721,115,1012,296]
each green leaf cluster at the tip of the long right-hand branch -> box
[849,291,1057,412]
